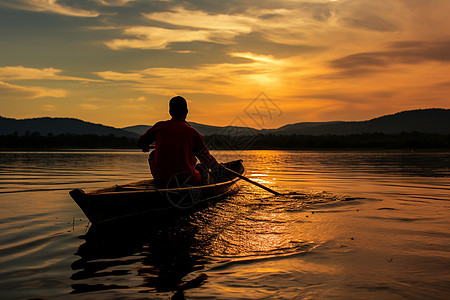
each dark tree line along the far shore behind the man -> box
[0,132,450,150]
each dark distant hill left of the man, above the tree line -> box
[0,117,137,137]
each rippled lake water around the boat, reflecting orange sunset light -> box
[0,150,450,299]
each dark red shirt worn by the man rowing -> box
[138,119,217,181]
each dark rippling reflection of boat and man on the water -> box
[71,217,207,299]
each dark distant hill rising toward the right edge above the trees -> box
[266,108,450,135]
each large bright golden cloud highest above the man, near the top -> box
[105,7,332,50]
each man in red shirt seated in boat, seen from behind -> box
[138,96,219,185]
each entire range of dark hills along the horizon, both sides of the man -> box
[0,108,450,138]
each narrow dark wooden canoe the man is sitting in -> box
[69,160,244,225]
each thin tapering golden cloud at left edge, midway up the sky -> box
[0,66,99,82]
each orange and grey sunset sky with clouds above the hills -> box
[0,0,450,128]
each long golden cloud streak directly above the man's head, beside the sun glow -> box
[95,52,290,97]
